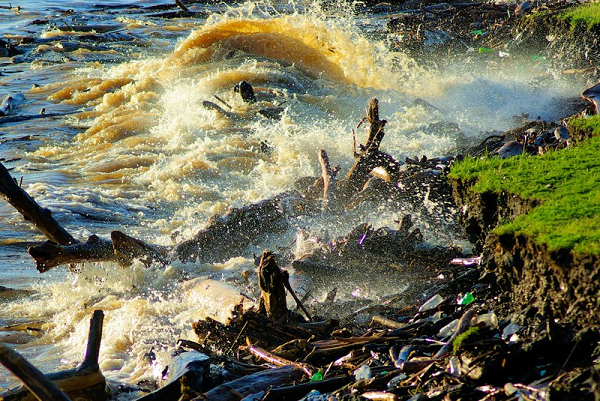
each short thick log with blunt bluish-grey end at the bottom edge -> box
[137,351,210,401]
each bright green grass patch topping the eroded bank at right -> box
[450,116,600,255]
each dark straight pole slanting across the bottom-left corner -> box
[0,344,71,401]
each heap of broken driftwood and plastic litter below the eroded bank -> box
[186,253,600,400]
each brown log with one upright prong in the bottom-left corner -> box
[0,310,108,401]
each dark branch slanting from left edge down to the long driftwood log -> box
[0,163,79,245]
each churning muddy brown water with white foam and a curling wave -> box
[0,0,582,397]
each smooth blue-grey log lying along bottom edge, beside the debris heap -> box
[199,366,304,401]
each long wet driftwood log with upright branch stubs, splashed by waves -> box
[0,99,436,270]
